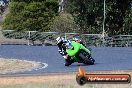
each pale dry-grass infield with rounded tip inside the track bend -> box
[0,58,44,74]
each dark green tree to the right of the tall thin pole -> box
[106,0,132,35]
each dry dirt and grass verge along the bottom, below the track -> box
[0,70,132,88]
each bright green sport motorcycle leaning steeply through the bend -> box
[66,41,95,65]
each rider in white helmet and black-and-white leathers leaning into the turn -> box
[56,37,94,66]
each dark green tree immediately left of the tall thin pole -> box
[66,0,103,33]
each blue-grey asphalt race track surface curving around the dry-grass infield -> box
[0,45,132,75]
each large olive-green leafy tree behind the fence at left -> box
[3,0,59,32]
